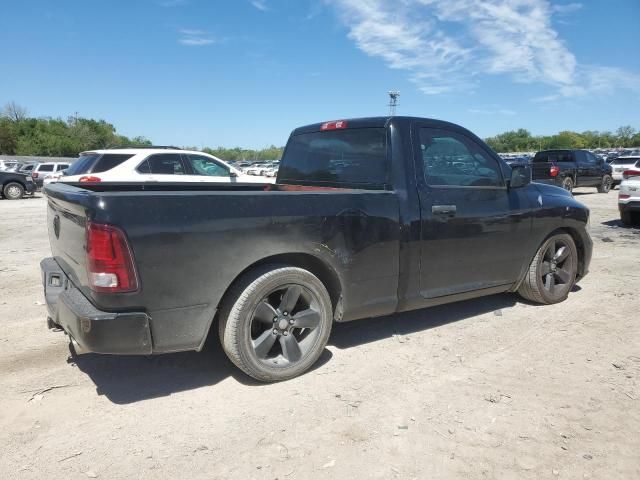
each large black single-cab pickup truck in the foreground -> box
[41,117,592,381]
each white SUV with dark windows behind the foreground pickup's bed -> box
[58,147,273,183]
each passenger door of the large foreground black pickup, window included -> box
[413,124,532,298]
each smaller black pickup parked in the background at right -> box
[531,150,613,193]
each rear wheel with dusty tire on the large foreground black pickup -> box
[219,265,333,382]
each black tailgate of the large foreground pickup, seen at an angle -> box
[46,184,91,287]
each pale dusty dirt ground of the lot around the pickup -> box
[0,189,640,480]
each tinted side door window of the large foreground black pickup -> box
[420,128,504,187]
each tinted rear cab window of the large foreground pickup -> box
[278,128,387,188]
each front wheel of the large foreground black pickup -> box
[518,233,578,305]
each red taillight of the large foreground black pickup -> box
[87,222,138,293]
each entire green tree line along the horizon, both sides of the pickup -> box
[0,102,640,158]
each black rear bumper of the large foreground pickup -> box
[40,258,153,355]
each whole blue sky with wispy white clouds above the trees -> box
[0,0,640,148]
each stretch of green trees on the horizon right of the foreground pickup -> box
[485,126,640,153]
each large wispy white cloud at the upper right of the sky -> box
[326,0,640,97]
